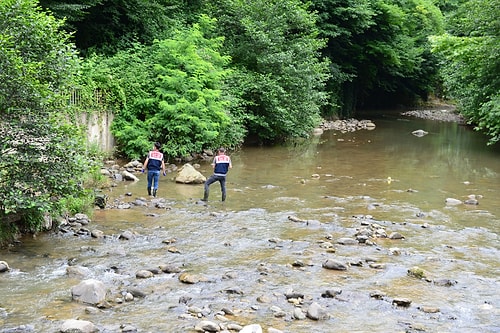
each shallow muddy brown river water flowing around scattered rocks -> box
[0,113,500,333]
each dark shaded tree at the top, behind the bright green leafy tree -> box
[40,0,188,56]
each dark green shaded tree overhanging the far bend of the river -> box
[312,0,443,116]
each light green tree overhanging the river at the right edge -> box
[432,0,500,144]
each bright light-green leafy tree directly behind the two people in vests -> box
[85,16,245,158]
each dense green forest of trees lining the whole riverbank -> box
[0,0,500,244]
